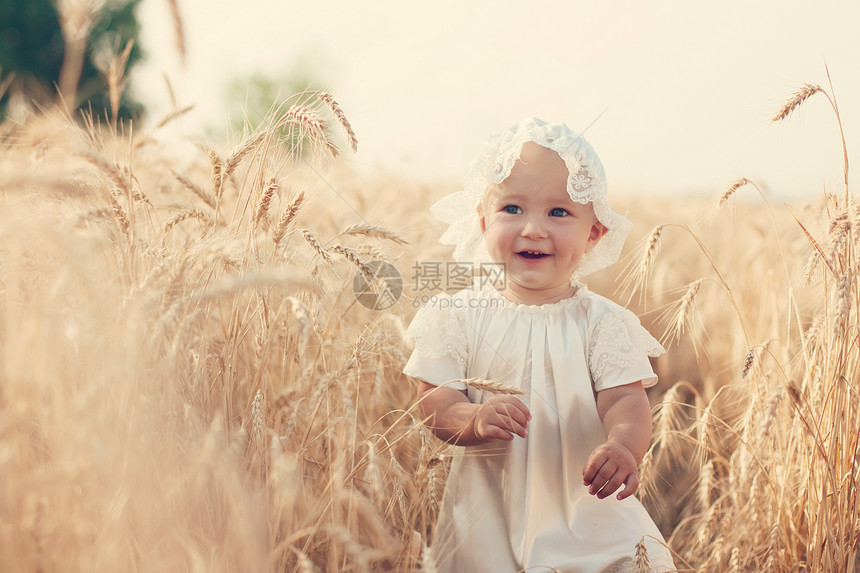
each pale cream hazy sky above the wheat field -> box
[133,0,860,200]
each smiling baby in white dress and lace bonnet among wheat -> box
[404,119,674,573]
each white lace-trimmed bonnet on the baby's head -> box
[430,117,632,279]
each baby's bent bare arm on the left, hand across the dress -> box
[418,380,531,446]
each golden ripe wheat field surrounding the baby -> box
[0,77,860,573]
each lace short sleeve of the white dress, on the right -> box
[588,309,665,391]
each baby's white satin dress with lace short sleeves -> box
[404,285,674,573]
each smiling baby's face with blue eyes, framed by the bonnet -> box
[478,142,606,304]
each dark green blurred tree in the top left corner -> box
[0,0,143,119]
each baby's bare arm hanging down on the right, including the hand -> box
[582,382,651,499]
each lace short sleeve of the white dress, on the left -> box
[403,294,469,390]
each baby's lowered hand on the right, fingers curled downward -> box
[582,442,639,499]
